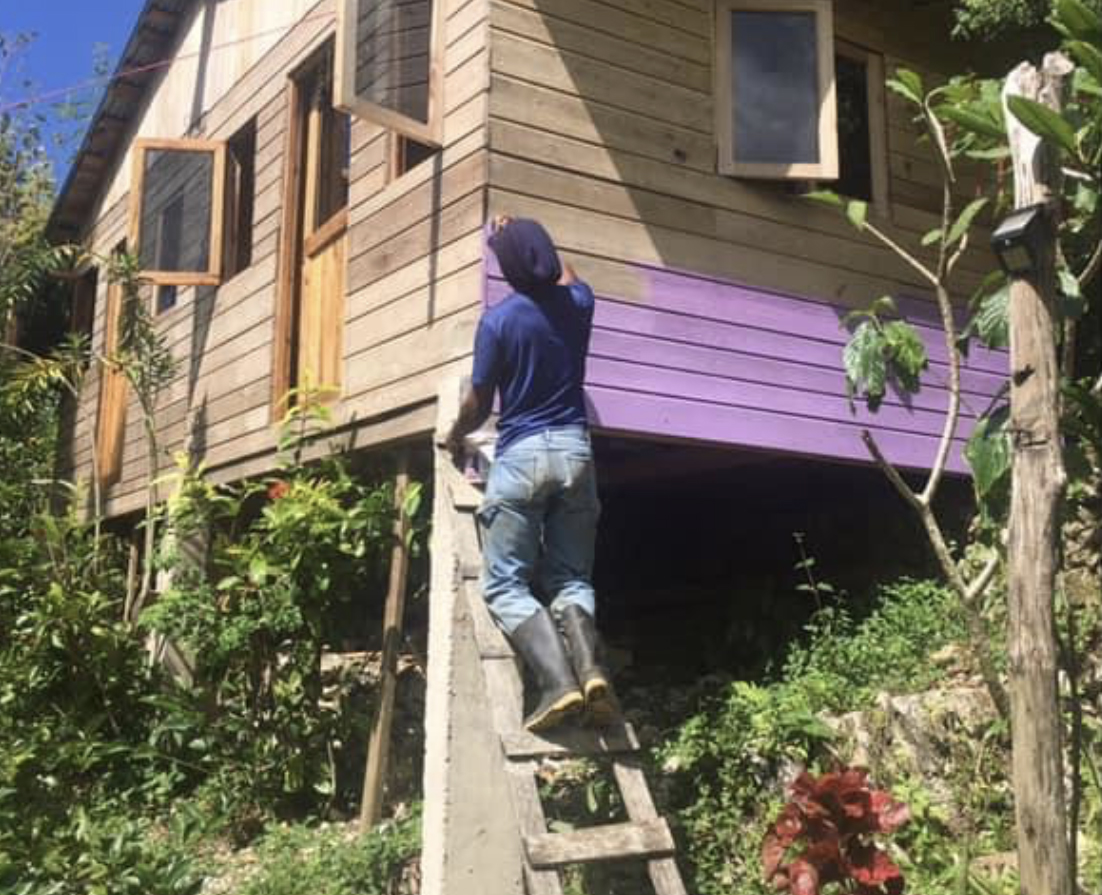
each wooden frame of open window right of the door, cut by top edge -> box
[333,0,444,147]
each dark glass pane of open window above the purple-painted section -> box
[731,11,819,164]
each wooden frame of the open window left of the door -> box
[130,137,226,287]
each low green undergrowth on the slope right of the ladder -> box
[658,580,982,895]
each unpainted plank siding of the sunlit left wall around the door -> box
[74,0,488,515]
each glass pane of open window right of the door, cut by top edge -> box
[355,0,432,125]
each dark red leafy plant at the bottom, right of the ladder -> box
[761,767,910,895]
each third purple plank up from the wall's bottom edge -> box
[590,328,985,418]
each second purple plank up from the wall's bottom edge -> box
[585,358,972,438]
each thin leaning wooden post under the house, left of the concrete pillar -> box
[359,452,410,830]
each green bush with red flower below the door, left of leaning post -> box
[141,402,417,840]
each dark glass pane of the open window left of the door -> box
[138,149,214,273]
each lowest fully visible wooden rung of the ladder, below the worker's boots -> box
[525,818,674,869]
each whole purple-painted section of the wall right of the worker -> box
[486,252,1007,472]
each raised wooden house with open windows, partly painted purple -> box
[51,0,1005,516]
